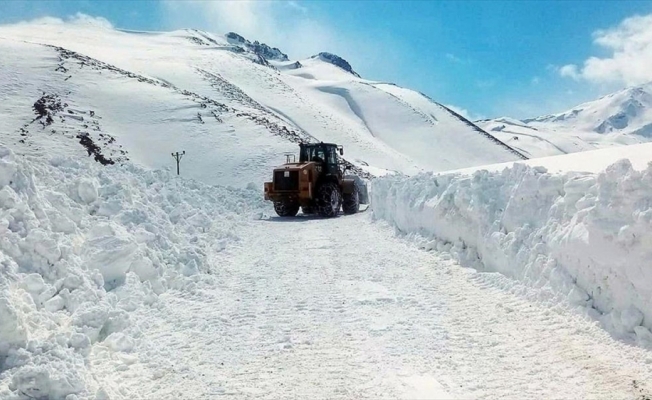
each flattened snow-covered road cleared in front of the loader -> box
[108,213,652,399]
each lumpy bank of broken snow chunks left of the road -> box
[0,146,262,400]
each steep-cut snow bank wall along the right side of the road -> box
[372,160,652,346]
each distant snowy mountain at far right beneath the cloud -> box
[476,83,652,157]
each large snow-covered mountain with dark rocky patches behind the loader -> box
[0,19,523,186]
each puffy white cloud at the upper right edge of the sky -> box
[558,14,652,85]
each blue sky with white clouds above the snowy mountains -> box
[0,0,652,118]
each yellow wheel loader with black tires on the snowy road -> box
[265,143,369,218]
